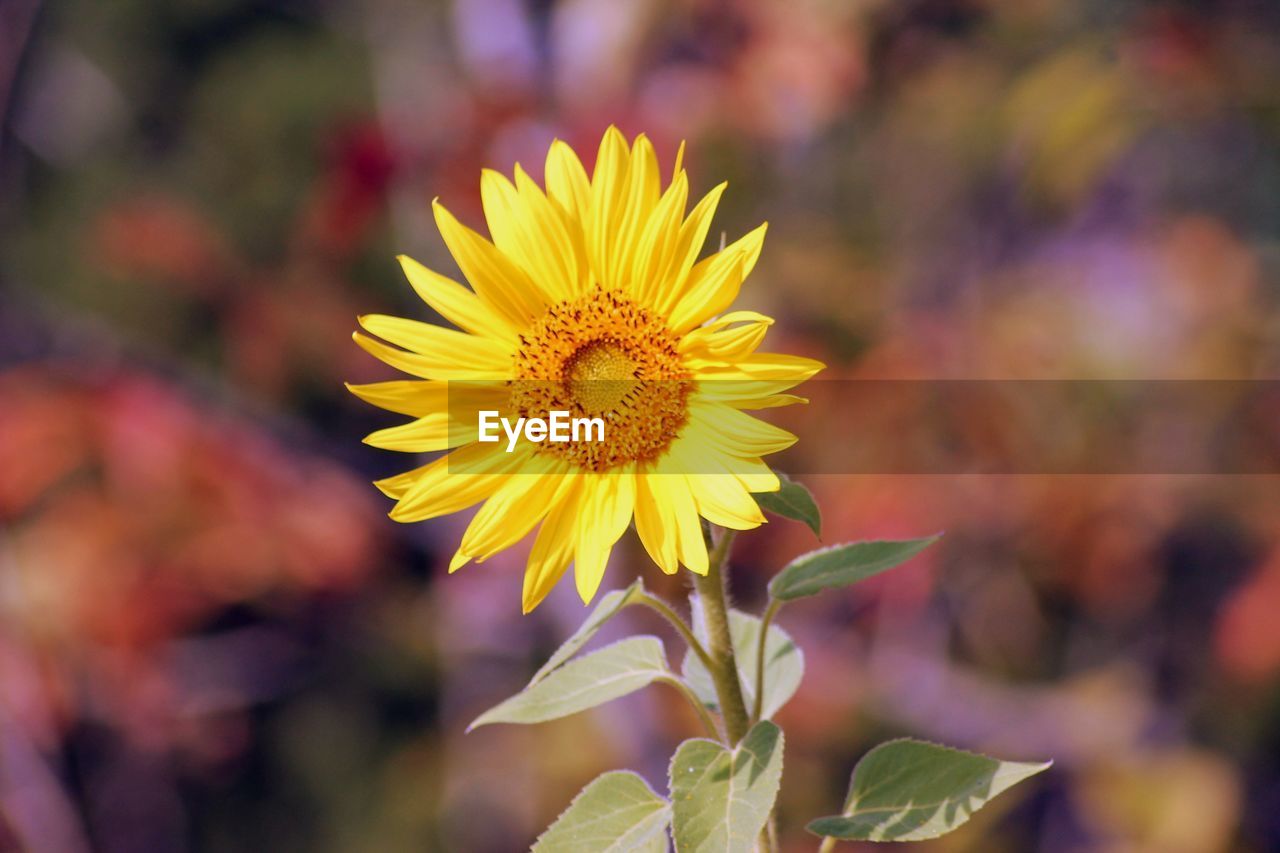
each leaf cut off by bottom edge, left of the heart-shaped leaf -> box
[531,770,671,853]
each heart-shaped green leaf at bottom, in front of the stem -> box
[671,720,783,853]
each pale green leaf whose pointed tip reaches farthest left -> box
[467,637,675,731]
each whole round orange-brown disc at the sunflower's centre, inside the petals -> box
[511,288,692,471]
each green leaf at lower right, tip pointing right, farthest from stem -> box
[809,739,1053,841]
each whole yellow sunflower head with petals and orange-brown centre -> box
[348,127,823,612]
